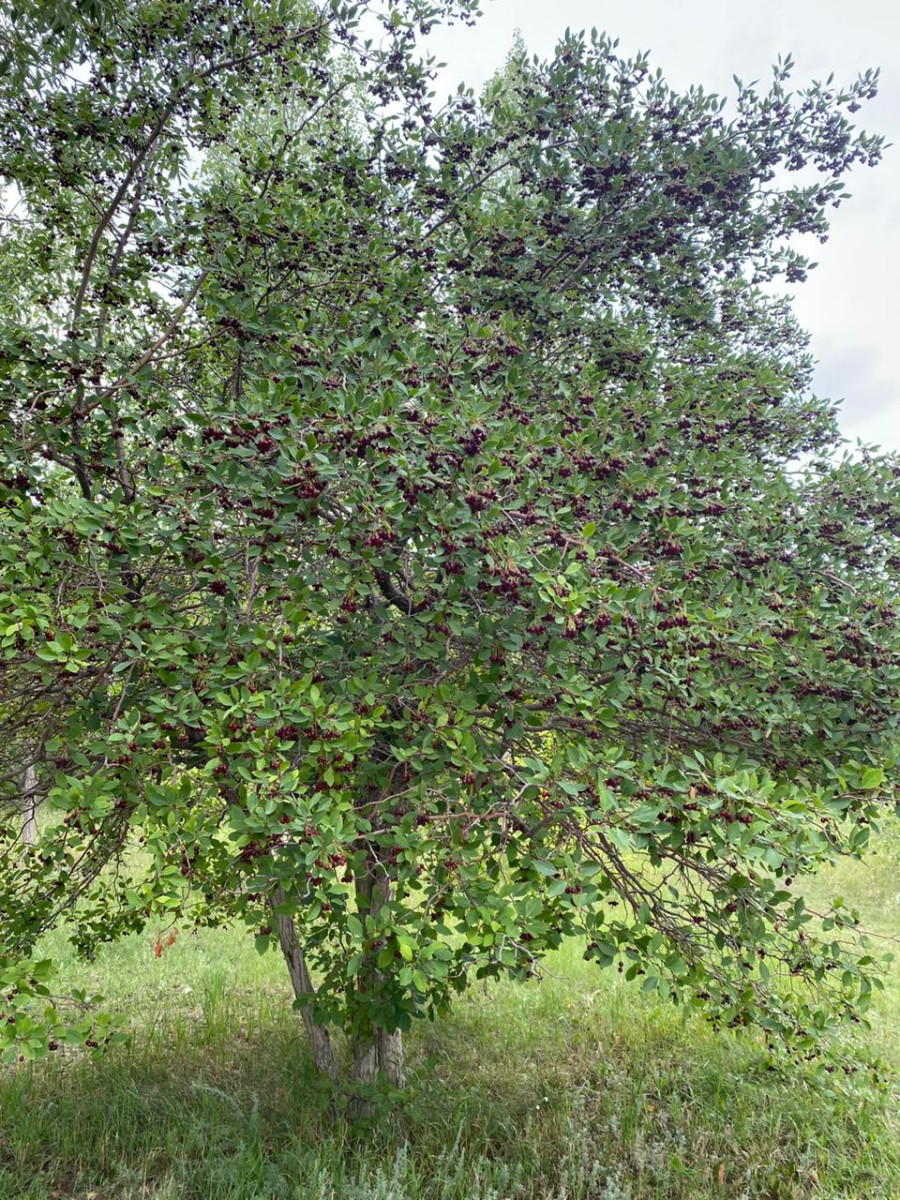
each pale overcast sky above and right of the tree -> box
[430,0,900,450]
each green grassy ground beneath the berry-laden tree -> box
[0,854,900,1200]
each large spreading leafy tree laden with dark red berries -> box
[0,0,900,1099]
